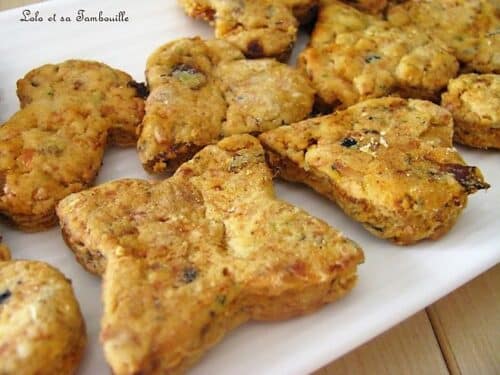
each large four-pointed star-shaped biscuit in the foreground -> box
[58,135,363,375]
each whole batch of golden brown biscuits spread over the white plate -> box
[0,0,500,375]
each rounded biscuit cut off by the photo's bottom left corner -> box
[0,260,86,375]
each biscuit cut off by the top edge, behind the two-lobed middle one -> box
[179,0,317,61]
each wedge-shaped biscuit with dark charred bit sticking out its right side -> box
[260,98,489,245]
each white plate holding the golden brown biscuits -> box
[0,0,500,375]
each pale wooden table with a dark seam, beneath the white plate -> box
[0,0,500,375]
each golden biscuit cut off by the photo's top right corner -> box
[387,0,500,73]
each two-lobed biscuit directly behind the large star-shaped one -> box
[137,38,314,173]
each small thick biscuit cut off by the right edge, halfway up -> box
[441,74,500,149]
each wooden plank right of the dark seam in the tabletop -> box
[427,265,500,375]
